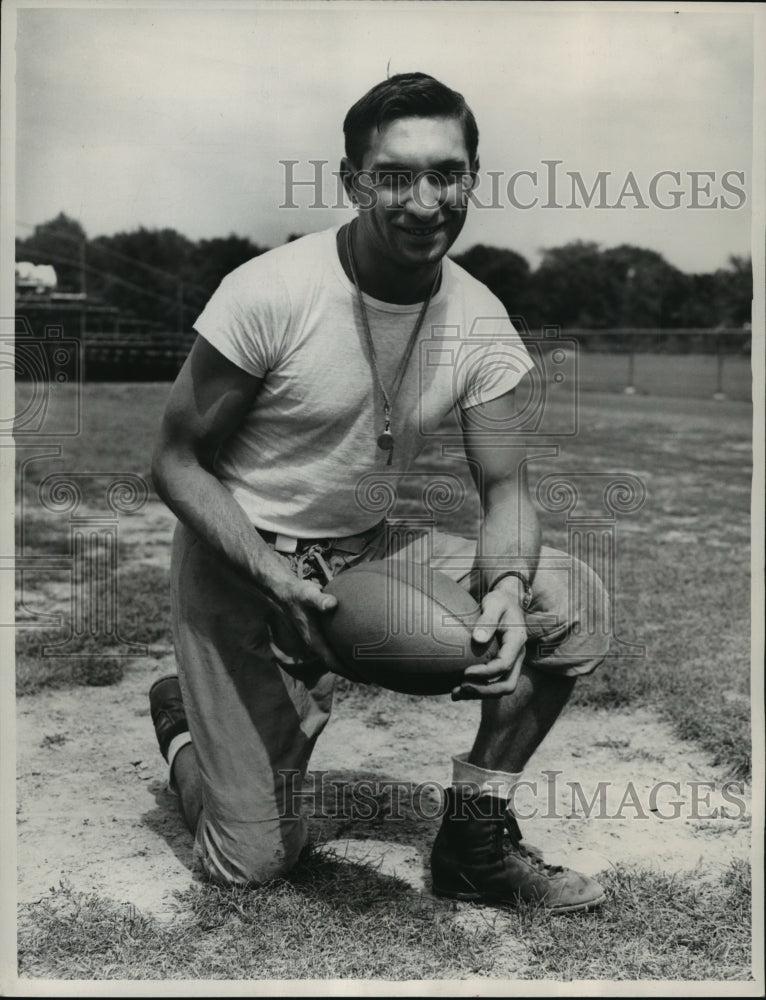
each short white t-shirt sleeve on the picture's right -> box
[457,320,534,409]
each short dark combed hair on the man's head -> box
[343,73,479,167]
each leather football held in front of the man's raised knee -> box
[321,559,498,695]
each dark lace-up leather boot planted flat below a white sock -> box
[431,788,605,913]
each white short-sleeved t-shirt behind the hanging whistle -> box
[195,228,533,538]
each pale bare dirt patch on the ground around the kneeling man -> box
[17,658,750,917]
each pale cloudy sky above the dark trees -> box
[7,0,756,271]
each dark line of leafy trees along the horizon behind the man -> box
[16,213,752,330]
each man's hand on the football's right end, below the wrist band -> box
[452,577,527,701]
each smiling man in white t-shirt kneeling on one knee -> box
[151,73,608,911]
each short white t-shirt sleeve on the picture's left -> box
[194,257,290,378]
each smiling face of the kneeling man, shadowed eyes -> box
[344,117,476,270]
